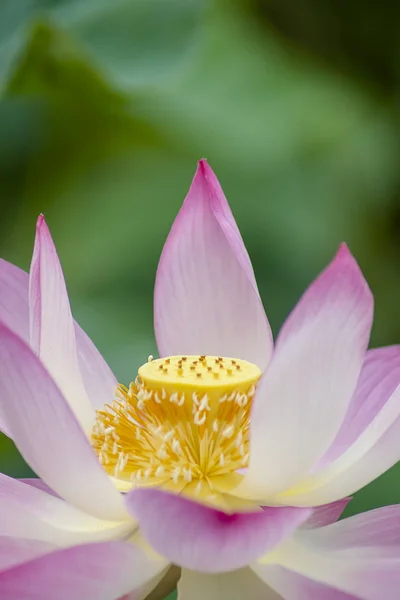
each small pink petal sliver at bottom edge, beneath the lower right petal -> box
[254,565,360,600]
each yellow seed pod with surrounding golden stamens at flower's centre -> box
[91,356,261,510]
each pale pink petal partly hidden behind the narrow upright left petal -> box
[0,259,117,420]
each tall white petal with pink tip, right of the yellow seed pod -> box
[238,245,373,496]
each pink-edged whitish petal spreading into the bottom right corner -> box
[255,506,400,600]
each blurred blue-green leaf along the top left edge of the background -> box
[0,0,205,88]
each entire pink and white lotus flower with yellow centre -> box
[0,161,400,600]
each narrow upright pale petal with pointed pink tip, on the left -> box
[29,215,94,432]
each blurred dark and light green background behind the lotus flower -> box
[0,0,400,596]
